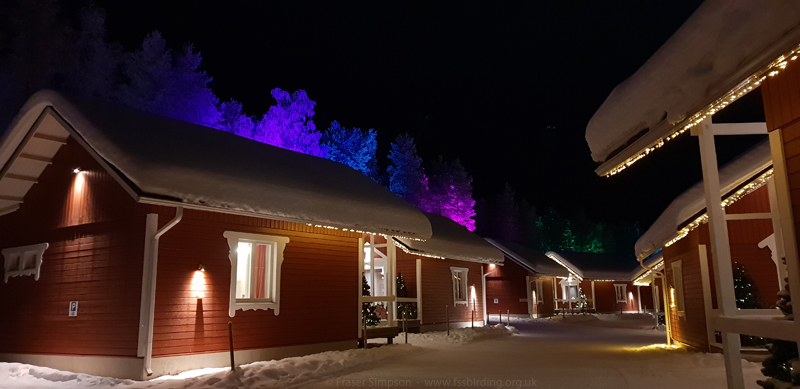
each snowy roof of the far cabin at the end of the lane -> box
[545,251,640,281]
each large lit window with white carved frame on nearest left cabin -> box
[223,231,289,317]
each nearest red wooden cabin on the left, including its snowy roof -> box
[0,91,431,379]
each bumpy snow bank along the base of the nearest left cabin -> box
[0,344,419,389]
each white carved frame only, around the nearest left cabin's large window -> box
[222,231,289,317]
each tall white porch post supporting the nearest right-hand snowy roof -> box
[692,117,744,389]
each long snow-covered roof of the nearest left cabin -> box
[0,91,431,239]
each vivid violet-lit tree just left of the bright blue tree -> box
[253,88,328,158]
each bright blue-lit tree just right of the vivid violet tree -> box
[321,121,378,181]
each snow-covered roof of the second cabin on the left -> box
[395,213,503,264]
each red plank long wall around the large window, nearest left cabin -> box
[148,206,361,356]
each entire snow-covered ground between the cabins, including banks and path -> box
[0,315,762,389]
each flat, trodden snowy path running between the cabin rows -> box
[304,321,761,389]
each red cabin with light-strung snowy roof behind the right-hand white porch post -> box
[636,142,785,351]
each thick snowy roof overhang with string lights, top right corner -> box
[586,0,800,175]
